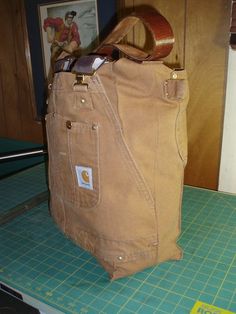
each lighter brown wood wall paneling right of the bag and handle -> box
[123,0,231,190]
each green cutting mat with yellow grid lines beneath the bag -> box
[0,164,236,314]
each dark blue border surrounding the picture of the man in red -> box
[24,0,117,121]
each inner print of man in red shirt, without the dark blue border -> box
[38,0,99,77]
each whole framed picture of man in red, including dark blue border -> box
[24,0,117,120]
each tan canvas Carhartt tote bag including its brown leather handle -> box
[46,11,188,279]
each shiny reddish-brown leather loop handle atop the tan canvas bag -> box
[95,10,175,61]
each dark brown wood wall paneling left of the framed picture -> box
[0,0,43,143]
